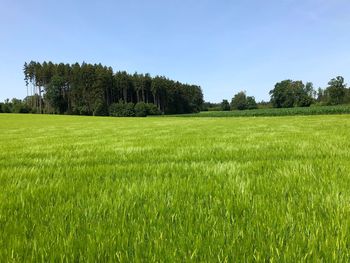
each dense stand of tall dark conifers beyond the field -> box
[19,61,203,116]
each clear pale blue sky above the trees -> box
[0,0,350,102]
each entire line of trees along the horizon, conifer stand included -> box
[0,64,350,116]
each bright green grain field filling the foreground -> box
[0,114,350,262]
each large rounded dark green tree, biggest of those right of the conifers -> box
[270,79,314,108]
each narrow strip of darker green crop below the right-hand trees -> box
[174,105,350,117]
